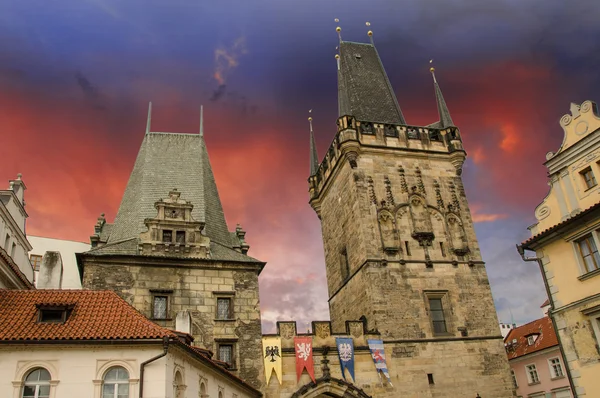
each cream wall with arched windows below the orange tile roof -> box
[0,343,255,398]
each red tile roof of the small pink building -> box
[504,316,558,360]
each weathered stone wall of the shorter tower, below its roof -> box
[83,255,264,389]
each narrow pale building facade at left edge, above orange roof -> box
[0,174,33,289]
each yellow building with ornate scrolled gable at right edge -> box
[519,101,600,397]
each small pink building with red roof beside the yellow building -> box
[504,317,573,398]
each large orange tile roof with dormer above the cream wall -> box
[0,289,176,341]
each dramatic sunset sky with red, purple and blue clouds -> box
[0,0,600,332]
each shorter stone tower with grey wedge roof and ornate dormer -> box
[78,104,265,388]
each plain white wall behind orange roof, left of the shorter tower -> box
[27,235,91,289]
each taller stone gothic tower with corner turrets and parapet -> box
[309,41,511,397]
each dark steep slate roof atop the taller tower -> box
[338,41,406,124]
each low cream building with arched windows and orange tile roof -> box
[0,290,262,398]
